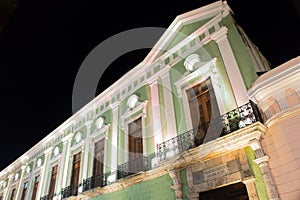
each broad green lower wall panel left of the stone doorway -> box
[91,175,176,200]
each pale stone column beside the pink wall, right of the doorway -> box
[250,139,280,200]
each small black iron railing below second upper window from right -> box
[117,155,150,179]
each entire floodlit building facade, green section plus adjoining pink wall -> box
[0,1,300,200]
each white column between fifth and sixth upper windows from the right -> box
[36,147,53,199]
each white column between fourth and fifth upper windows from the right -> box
[55,134,73,199]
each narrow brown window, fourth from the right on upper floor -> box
[71,152,81,196]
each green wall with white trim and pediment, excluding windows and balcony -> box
[0,1,276,200]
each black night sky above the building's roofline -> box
[0,0,300,170]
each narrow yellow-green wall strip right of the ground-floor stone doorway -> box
[245,147,269,200]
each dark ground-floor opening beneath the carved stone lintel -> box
[199,182,249,200]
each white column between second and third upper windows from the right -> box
[110,105,119,177]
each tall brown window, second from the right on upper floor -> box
[128,117,143,173]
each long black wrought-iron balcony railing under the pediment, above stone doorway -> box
[157,102,262,161]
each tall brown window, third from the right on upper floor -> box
[93,139,105,187]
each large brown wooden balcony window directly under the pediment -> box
[187,78,219,145]
